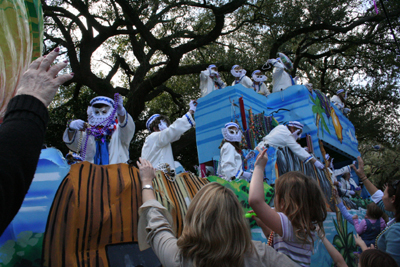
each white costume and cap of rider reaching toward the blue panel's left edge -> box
[141,112,196,170]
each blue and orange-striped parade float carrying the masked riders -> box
[0,82,365,266]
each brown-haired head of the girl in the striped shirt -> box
[274,172,327,242]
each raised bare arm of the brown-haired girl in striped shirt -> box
[249,149,283,236]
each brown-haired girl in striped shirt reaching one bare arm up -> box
[249,165,327,266]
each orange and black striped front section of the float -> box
[42,162,208,267]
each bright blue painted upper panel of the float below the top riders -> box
[195,84,360,164]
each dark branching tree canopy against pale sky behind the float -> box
[42,0,400,176]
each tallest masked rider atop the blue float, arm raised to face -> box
[265,53,297,93]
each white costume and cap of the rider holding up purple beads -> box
[63,96,135,164]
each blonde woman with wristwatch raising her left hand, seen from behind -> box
[138,159,297,267]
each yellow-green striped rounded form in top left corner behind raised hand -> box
[0,0,43,123]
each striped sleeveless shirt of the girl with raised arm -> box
[273,212,314,266]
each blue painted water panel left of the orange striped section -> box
[0,148,70,266]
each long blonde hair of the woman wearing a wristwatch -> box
[177,183,254,267]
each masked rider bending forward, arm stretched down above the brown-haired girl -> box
[256,121,325,170]
